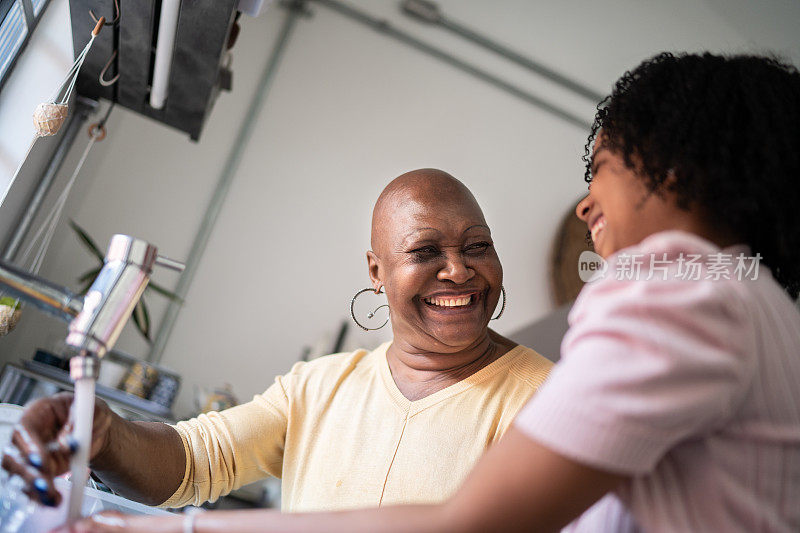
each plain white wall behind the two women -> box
[0,0,800,414]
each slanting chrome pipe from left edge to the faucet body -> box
[0,261,83,322]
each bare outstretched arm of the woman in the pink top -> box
[70,427,624,533]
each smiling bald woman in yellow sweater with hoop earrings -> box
[3,169,551,511]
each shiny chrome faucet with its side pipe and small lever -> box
[0,235,184,380]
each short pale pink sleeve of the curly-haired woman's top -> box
[515,278,755,475]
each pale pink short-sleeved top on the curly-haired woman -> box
[515,231,800,532]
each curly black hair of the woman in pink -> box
[583,53,800,298]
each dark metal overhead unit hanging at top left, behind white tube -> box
[69,0,237,141]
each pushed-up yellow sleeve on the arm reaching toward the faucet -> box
[160,364,299,508]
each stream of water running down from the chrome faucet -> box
[67,377,94,522]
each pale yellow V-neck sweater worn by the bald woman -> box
[162,343,552,512]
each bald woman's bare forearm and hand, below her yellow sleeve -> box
[3,393,186,504]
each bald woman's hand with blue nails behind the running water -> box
[2,393,114,505]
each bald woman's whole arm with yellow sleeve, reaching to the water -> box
[3,366,294,507]
